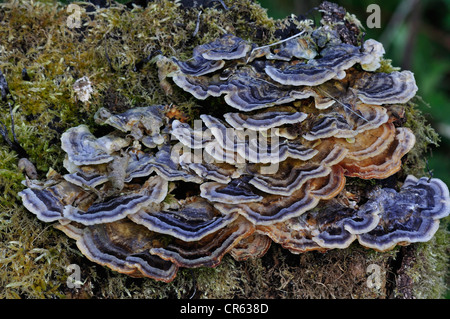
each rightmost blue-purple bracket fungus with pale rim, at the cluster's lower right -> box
[358,175,450,251]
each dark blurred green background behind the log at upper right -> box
[258,0,450,185]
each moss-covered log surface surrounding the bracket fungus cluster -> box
[0,0,449,298]
